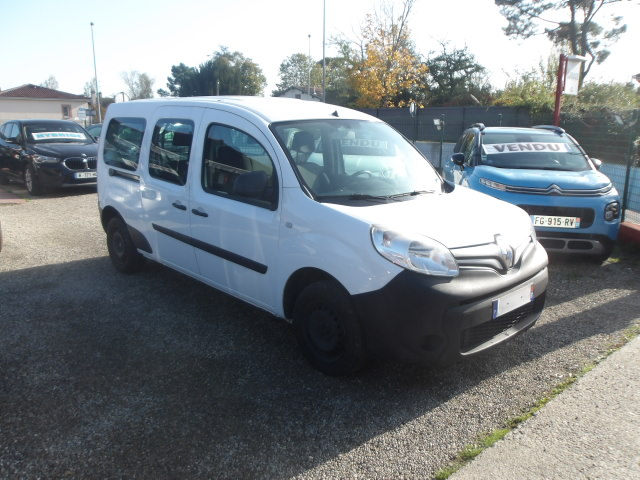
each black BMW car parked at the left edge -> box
[0,120,98,195]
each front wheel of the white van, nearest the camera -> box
[293,280,367,376]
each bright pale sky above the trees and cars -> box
[0,0,640,96]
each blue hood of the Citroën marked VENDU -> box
[476,165,611,190]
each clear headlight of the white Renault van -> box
[371,225,459,277]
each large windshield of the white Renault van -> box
[273,119,442,201]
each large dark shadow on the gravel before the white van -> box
[0,249,638,478]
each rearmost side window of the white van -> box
[103,118,147,171]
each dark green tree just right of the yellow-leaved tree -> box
[427,43,491,106]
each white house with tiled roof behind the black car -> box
[0,84,91,124]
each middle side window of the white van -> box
[149,118,193,185]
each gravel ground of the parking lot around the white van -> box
[0,189,640,479]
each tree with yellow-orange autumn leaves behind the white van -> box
[349,0,427,108]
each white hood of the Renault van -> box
[325,186,533,249]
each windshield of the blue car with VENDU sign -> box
[480,131,591,171]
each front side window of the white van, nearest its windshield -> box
[202,124,277,209]
